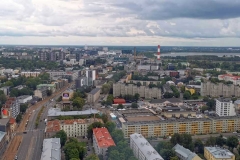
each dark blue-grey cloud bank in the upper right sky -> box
[115,0,240,20]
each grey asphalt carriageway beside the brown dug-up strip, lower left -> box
[17,100,56,160]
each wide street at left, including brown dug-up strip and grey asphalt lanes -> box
[2,83,73,160]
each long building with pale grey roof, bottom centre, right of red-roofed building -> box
[130,133,163,160]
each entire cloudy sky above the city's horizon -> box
[0,0,240,46]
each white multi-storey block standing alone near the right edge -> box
[216,98,236,116]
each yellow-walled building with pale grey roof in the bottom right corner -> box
[204,147,235,160]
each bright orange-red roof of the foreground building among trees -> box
[93,127,116,148]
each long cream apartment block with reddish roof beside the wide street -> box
[45,118,103,138]
